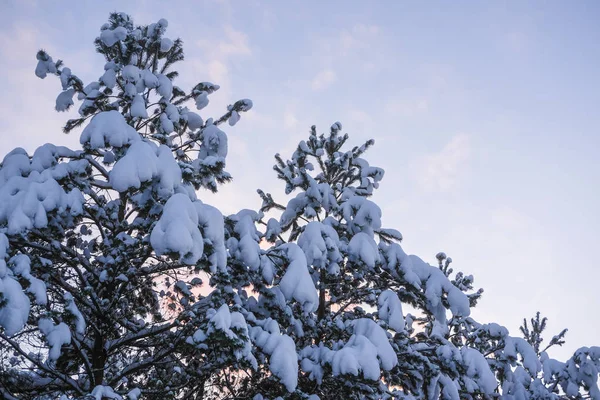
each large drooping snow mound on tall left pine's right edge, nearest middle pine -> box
[150,193,204,264]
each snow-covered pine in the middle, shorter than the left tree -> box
[202,123,496,399]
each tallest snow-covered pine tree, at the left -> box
[0,13,252,399]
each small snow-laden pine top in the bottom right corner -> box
[454,312,600,400]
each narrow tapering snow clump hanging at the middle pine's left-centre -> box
[279,243,319,312]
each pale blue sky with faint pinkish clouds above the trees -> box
[0,1,600,358]
